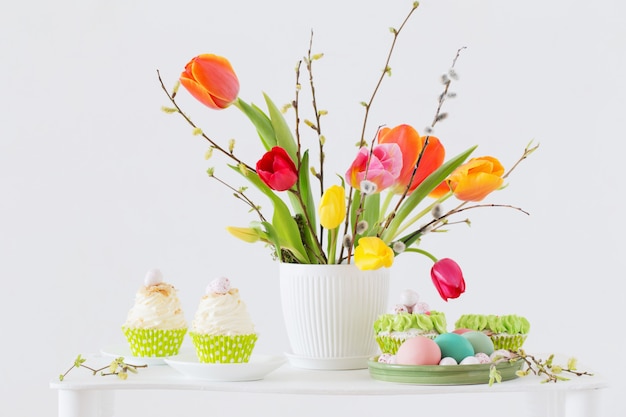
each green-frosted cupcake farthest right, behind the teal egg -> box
[454,314,530,350]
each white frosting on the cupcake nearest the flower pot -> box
[191,288,255,336]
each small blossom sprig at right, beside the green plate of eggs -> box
[489,349,593,386]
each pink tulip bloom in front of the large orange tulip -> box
[346,143,402,192]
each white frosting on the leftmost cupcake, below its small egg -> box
[124,283,187,330]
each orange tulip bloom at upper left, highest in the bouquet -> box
[180,54,239,110]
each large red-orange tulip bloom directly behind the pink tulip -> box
[378,124,445,194]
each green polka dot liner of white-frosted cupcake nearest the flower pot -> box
[189,332,258,363]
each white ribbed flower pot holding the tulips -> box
[280,263,390,369]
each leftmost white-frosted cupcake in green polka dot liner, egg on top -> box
[122,269,187,357]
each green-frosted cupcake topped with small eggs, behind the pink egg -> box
[374,290,447,355]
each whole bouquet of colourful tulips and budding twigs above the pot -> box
[159,2,537,300]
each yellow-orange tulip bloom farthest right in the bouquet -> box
[448,156,504,201]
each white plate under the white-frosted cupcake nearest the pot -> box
[165,352,287,381]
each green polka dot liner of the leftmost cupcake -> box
[122,327,187,358]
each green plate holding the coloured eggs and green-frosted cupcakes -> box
[367,357,524,385]
